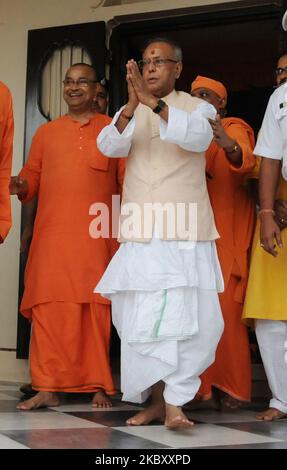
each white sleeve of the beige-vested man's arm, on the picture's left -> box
[97,108,135,157]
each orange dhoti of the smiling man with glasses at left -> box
[30,302,116,395]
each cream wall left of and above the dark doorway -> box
[0,0,240,381]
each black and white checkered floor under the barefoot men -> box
[0,382,287,449]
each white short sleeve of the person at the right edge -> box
[253,91,283,160]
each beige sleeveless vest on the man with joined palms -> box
[119,91,218,242]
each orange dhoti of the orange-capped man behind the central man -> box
[198,275,251,401]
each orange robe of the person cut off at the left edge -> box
[0,82,14,243]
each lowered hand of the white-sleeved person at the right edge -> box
[260,213,283,257]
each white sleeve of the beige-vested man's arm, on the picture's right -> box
[160,102,216,152]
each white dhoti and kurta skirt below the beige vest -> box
[95,238,226,406]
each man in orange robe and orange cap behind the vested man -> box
[191,76,256,409]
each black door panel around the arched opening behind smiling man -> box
[16,21,107,359]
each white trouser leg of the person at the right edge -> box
[255,320,287,413]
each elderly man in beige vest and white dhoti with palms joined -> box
[96,39,223,428]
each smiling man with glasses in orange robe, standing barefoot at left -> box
[10,64,124,410]
